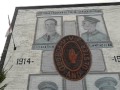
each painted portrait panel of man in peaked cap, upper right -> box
[78,15,109,42]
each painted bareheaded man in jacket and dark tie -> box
[35,18,61,44]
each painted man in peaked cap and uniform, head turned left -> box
[81,16,109,42]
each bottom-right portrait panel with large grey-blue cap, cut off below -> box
[86,73,120,90]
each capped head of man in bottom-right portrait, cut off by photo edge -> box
[95,77,118,90]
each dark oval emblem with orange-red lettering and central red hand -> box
[54,35,92,80]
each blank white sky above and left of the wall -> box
[0,0,120,56]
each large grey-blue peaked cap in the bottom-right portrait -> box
[95,77,117,88]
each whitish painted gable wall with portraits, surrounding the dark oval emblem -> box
[2,5,120,90]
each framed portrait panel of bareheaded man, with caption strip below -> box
[32,16,63,51]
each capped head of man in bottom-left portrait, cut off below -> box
[38,81,58,90]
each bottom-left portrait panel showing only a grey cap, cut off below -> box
[27,74,64,90]
